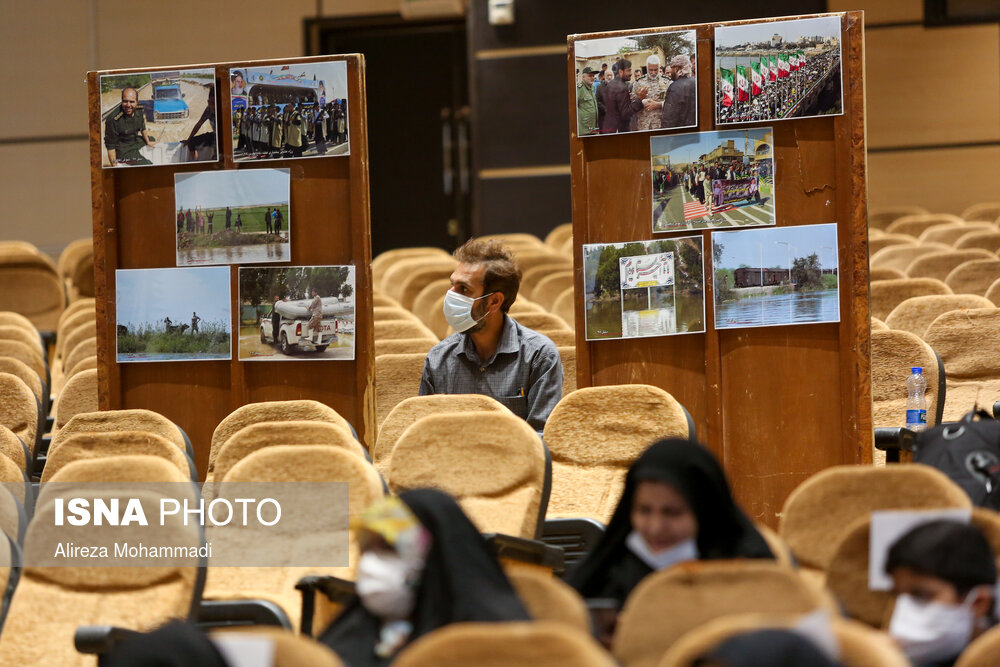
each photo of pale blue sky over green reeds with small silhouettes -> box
[115,266,232,364]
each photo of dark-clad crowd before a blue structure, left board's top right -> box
[229,60,351,162]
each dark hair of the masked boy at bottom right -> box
[885,520,997,597]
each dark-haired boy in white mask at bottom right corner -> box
[885,520,997,667]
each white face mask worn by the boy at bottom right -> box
[889,589,976,664]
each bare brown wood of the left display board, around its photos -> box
[87,54,374,478]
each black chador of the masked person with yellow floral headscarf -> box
[320,489,530,667]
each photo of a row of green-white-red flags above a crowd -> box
[714,16,844,125]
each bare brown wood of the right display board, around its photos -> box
[568,12,872,526]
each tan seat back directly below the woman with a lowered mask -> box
[612,560,832,667]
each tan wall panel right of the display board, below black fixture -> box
[866,24,1000,148]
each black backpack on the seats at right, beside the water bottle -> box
[913,410,1000,510]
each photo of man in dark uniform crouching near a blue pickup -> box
[100,69,219,168]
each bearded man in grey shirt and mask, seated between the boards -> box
[420,239,563,433]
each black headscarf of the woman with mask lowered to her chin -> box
[567,438,774,603]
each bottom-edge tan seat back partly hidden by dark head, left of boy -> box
[658,614,910,667]
